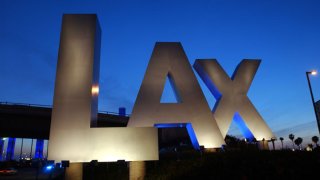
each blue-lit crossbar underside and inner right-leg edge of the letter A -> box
[154,123,200,150]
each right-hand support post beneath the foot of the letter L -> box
[129,161,146,180]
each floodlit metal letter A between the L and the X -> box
[128,43,224,148]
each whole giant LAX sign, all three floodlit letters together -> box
[48,14,273,162]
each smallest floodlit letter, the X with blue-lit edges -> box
[194,60,273,140]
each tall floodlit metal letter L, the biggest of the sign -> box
[48,15,158,162]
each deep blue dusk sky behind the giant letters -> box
[0,0,320,147]
